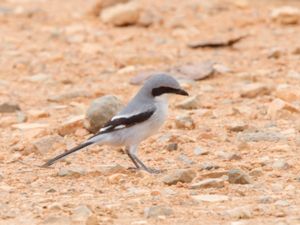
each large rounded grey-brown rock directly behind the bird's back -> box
[84,95,123,133]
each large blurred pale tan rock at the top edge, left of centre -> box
[100,1,141,26]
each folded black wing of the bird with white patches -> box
[88,108,155,140]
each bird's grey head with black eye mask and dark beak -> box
[143,74,189,98]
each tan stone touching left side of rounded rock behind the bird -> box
[58,115,85,136]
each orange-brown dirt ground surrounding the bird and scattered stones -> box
[0,0,300,224]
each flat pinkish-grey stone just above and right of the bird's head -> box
[175,61,215,80]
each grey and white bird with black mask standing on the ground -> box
[43,74,188,173]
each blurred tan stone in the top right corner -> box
[271,6,300,25]
